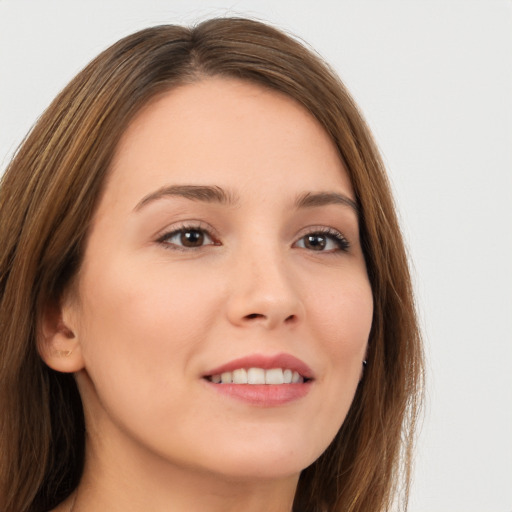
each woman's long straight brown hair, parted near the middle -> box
[0,18,423,512]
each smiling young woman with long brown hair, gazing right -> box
[0,19,422,512]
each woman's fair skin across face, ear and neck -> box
[41,78,373,512]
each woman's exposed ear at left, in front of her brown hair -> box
[37,297,84,373]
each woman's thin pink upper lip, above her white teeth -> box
[203,353,314,379]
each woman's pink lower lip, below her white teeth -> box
[205,381,312,407]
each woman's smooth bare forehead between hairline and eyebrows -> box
[107,78,353,206]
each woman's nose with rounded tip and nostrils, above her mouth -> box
[227,246,303,329]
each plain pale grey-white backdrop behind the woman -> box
[0,0,512,512]
